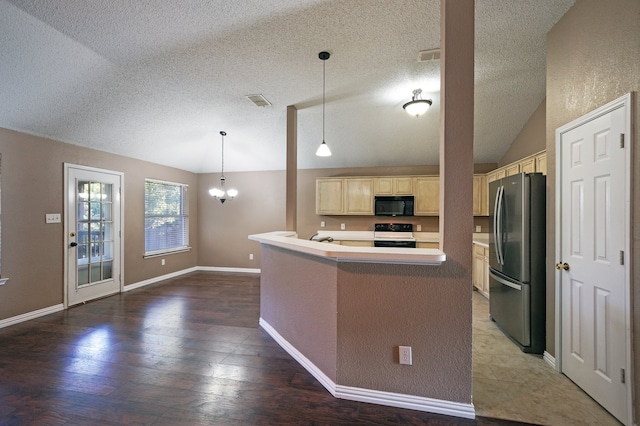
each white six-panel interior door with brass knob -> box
[556,97,632,424]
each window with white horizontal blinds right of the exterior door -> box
[144,179,189,256]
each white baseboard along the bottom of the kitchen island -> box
[260,318,476,419]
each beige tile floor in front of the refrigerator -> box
[473,291,620,426]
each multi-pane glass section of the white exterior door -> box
[76,180,114,287]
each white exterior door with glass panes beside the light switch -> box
[65,165,122,306]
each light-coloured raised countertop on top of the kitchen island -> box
[249,231,447,265]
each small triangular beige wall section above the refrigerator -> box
[498,99,547,167]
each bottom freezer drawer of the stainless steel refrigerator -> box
[489,271,531,346]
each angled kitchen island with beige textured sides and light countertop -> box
[249,232,475,418]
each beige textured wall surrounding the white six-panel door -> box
[546,0,640,412]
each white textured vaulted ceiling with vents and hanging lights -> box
[0,0,574,172]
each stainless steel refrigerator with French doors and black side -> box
[489,173,546,354]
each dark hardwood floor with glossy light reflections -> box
[0,272,518,425]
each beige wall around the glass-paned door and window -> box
[0,129,198,320]
